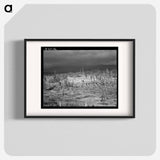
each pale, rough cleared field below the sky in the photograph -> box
[43,69,117,107]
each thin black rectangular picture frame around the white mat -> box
[24,39,135,118]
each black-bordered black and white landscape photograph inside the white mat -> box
[41,46,118,109]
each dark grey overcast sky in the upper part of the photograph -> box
[43,50,117,72]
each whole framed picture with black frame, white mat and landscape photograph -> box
[24,39,135,118]
